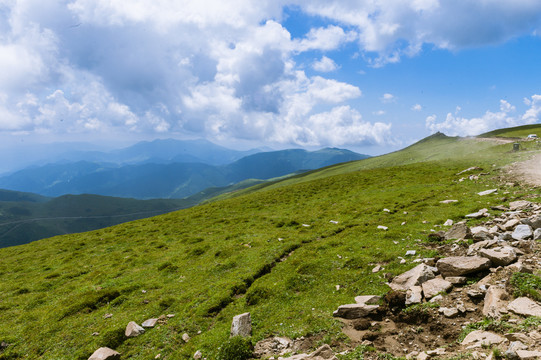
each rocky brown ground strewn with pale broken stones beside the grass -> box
[251,201,541,359]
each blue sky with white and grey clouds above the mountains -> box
[0,0,541,155]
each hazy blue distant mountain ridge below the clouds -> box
[0,144,368,199]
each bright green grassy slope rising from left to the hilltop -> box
[0,134,536,359]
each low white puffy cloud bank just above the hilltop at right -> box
[426,95,541,136]
